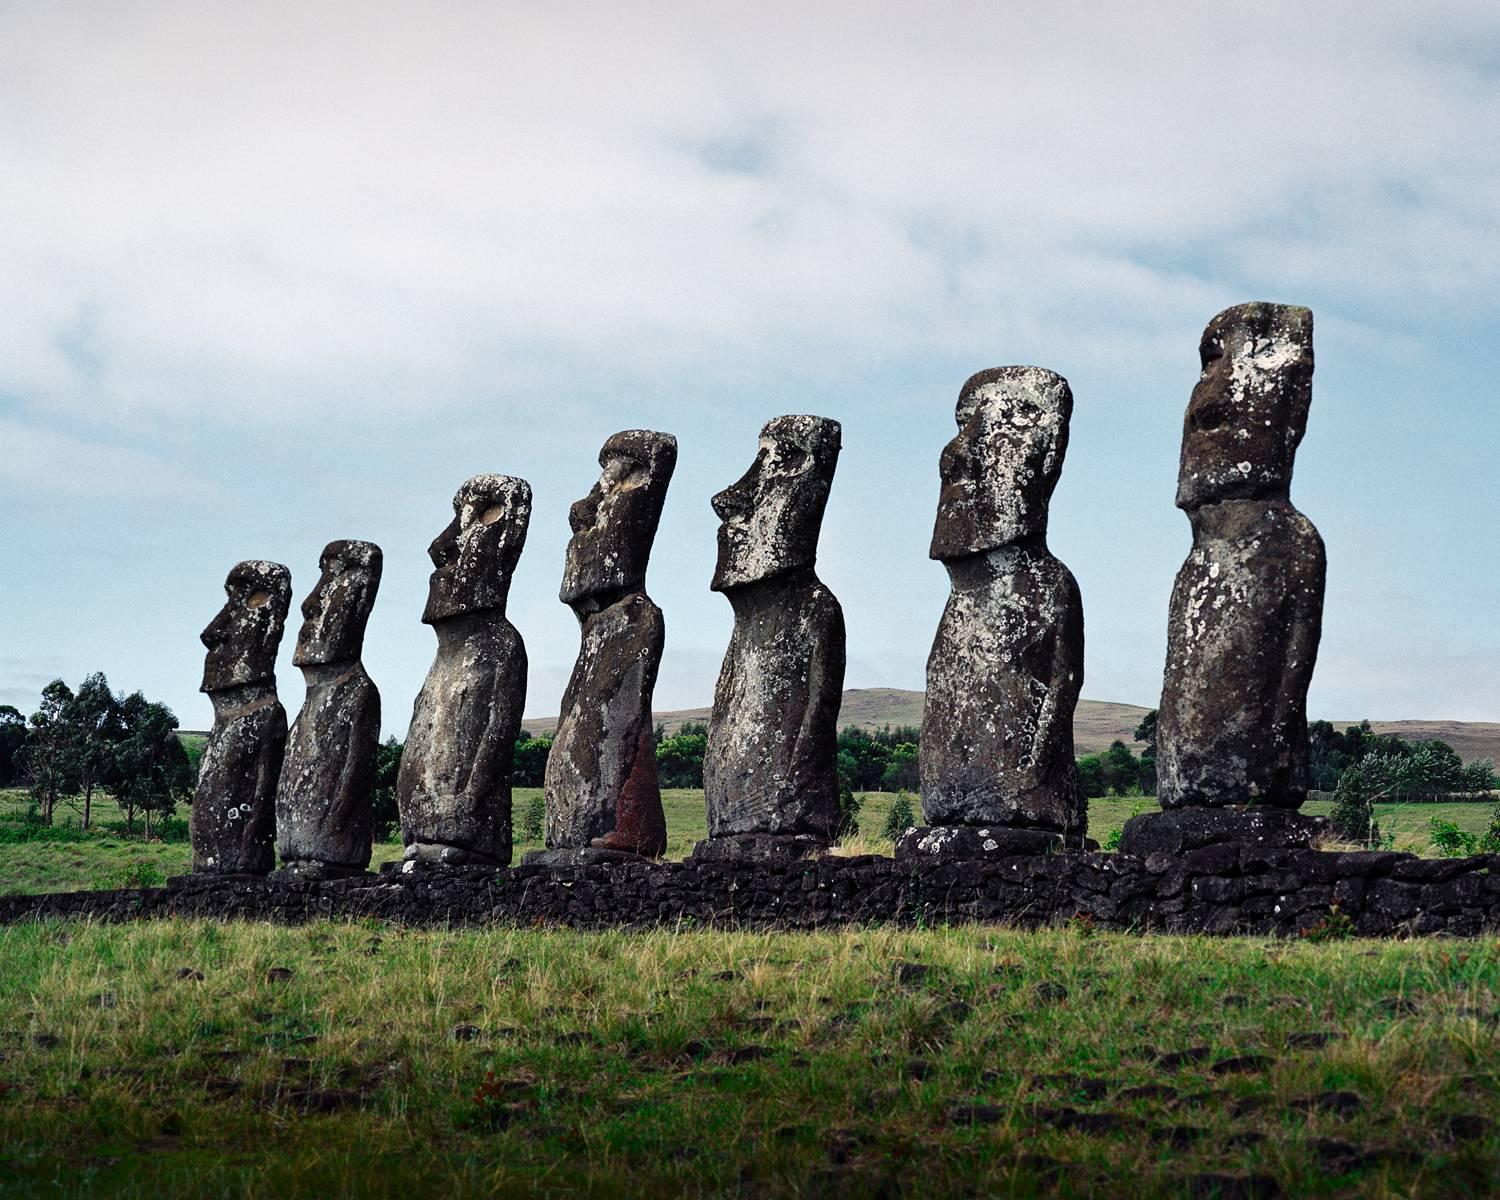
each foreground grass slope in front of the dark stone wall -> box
[0,921,1500,1200]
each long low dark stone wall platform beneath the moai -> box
[0,843,1500,936]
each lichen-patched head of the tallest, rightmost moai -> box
[1178,303,1313,510]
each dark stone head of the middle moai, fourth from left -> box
[558,429,677,611]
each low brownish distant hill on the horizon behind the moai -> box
[522,687,1500,762]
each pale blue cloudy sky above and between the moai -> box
[0,0,1500,735]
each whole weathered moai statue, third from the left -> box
[396,476,531,867]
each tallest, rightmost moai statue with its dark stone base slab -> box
[1121,303,1326,854]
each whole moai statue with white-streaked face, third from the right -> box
[693,417,845,860]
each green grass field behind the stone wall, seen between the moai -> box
[0,788,1496,896]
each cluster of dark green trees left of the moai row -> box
[0,671,197,836]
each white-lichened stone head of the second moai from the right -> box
[929,366,1073,560]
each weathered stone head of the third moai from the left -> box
[422,476,531,626]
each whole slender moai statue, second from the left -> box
[276,542,381,879]
